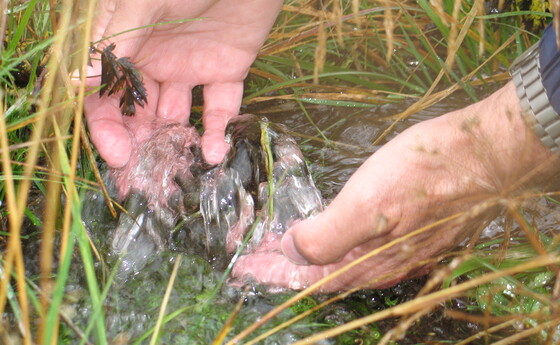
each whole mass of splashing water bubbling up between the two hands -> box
[84,115,323,279]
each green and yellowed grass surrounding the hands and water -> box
[0,0,560,344]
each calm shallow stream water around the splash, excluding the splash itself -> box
[17,84,540,345]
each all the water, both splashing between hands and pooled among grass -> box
[52,88,520,344]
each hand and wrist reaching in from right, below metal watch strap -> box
[233,82,559,292]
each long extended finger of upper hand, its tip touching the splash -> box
[202,81,243,164]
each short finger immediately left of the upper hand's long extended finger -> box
[157,82,192,124]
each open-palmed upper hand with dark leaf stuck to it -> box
[85,0,282,167]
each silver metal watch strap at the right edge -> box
[509,43,560,153]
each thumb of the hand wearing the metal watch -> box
[281,185,389,265]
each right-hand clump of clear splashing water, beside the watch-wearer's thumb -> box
[200,116,323,253]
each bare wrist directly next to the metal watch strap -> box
[448,82,556,182]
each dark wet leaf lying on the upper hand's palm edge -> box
[91,43,148,116]
